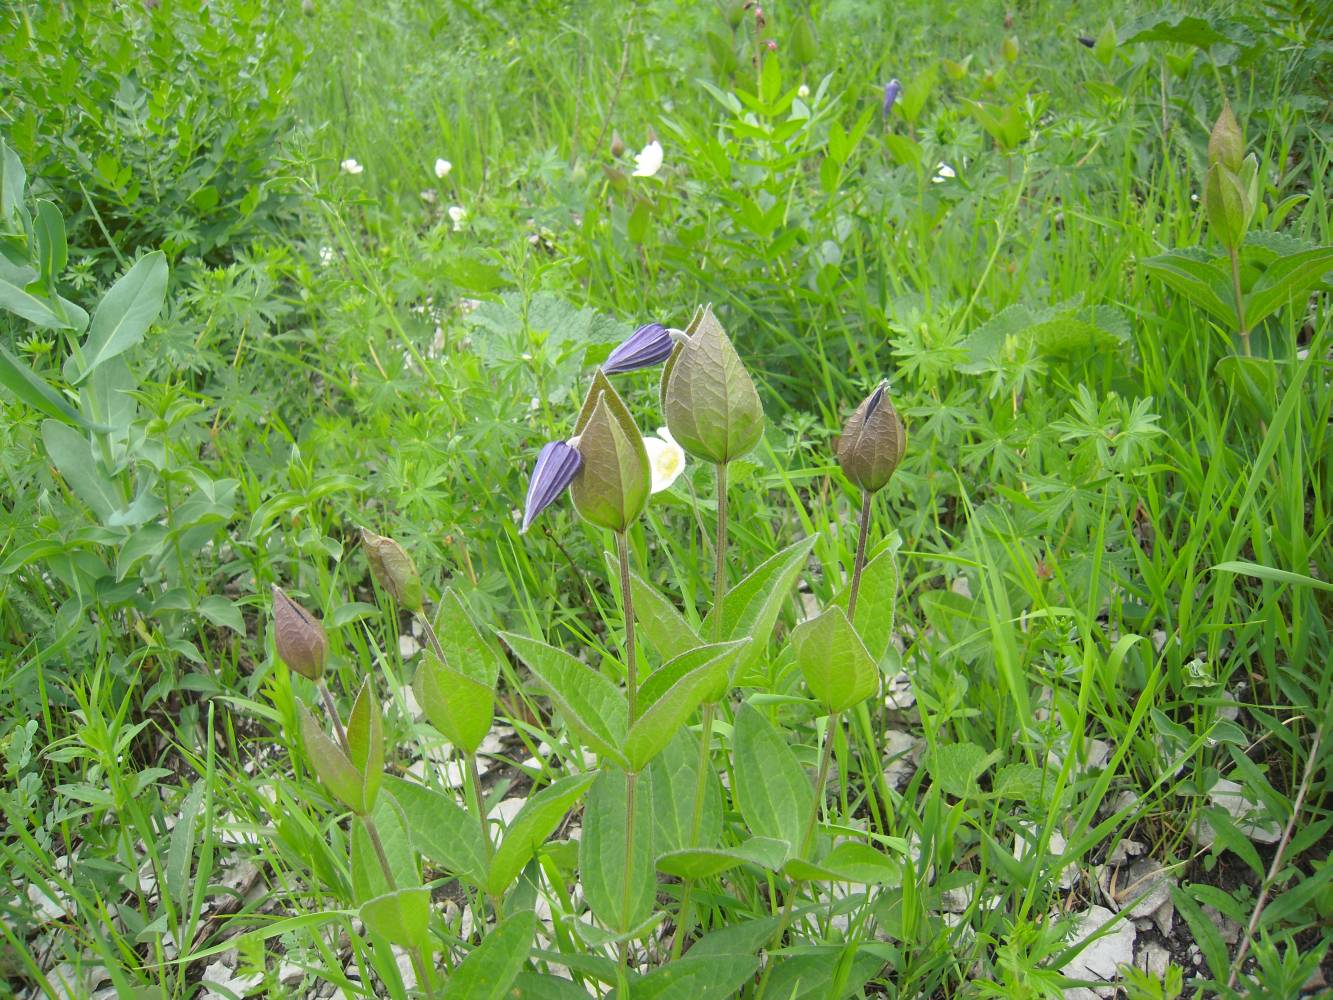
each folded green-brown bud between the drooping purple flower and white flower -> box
[569,369,652,531]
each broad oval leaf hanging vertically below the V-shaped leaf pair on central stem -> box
[579,769,657,932]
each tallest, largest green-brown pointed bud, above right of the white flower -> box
[661,305,764,464]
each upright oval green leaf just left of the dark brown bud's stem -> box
[732,703,814,856]
